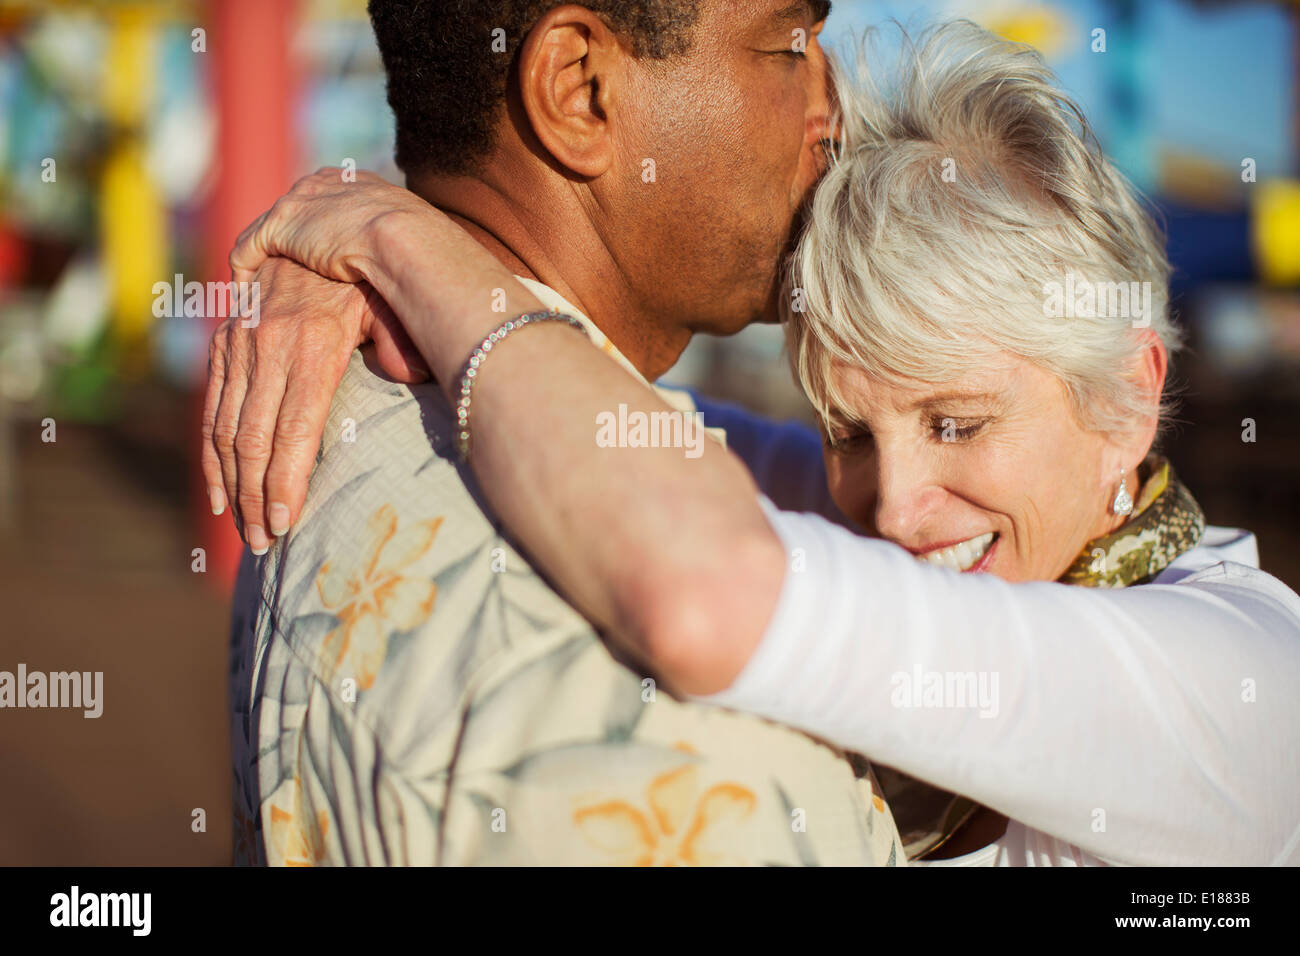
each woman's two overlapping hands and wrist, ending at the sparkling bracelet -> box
[202,169,541,553]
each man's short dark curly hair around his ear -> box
[369,0,701,174]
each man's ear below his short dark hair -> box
[519,4,628,178]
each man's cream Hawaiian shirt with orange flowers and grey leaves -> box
[231,282,905,866]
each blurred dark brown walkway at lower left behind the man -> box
[0,392,230,865]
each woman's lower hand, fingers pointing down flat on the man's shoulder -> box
[200,258,429,554]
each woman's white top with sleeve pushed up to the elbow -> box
[701,395,1300,865]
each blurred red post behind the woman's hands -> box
[194,0,298,591]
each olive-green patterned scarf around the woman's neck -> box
[875,455,1205,860]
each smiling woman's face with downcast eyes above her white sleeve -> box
[826,356,1132,581]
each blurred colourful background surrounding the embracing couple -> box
[0,0,1300,864]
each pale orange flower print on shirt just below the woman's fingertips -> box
[316,505,442,691]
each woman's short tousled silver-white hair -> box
[785,21,1179,431]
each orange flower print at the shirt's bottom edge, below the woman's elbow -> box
[573,748,758,866]
